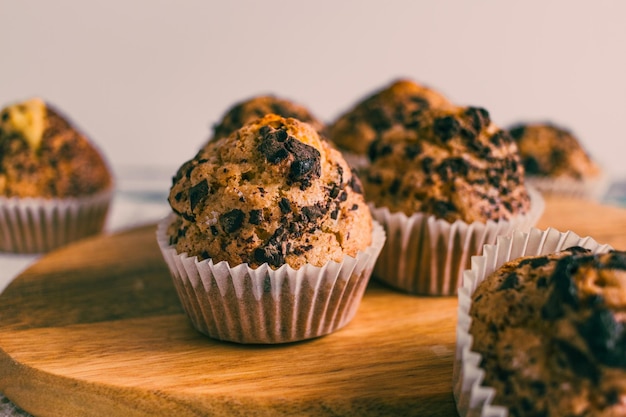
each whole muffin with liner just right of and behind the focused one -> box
[360,103,543,295]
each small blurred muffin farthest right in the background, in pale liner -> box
[509,123,606,199]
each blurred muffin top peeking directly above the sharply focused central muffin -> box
[213,95,325,139]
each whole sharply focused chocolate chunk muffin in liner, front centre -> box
[157,114,385,343]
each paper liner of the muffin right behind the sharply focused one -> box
[370,187,545,296]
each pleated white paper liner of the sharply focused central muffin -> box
[157,215,385,344]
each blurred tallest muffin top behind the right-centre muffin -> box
[329,79,453,155]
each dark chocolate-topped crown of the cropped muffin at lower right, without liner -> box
[470,247,626,417]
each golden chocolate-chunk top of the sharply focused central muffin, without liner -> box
[168,114,372,269]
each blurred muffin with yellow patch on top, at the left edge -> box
[0,98,113,253]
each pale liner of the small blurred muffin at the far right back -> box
[526,174,609,201]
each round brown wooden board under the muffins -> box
[0,199,626,417]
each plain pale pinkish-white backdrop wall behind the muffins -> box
[0,0,626,177]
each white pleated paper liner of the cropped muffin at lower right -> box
[452,228,612,417]
